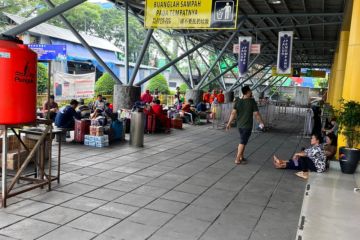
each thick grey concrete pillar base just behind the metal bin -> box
[113,84,141,112]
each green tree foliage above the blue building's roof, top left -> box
[0,0,149,64]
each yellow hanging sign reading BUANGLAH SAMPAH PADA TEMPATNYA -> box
[144,0,239,29]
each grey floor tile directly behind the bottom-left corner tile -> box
[5,200,53,217]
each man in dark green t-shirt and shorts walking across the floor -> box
[226,86,264,164]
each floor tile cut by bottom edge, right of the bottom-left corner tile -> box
[39,226,96,240]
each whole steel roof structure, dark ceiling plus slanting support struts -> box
[1,0,349,91]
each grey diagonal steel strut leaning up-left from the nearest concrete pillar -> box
[45,0,122,84]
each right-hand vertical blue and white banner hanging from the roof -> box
[276,31,294,74]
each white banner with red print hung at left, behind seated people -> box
[53,72,95,101]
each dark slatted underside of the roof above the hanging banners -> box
[112,0,346,67]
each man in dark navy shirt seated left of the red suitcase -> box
[55,99,79,129]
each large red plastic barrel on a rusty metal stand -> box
[0,39,37,125]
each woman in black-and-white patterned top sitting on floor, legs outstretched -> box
[274,134,326,179]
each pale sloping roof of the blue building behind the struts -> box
[2,12,121,52]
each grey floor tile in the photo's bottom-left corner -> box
[0,218,58,240]
